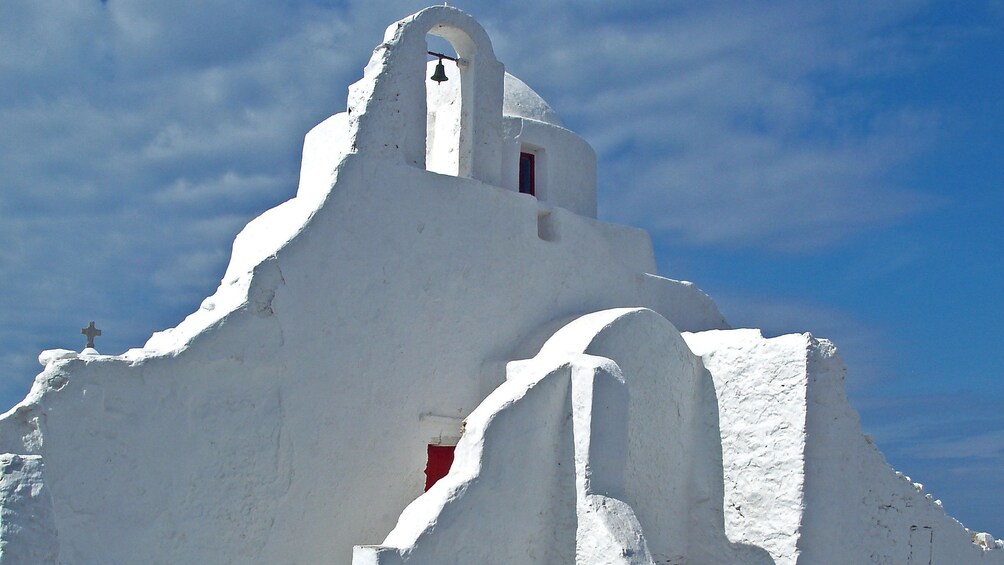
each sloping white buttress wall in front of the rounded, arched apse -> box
[352,355,654,565]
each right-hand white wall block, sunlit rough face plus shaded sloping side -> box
[685,330,1004,565]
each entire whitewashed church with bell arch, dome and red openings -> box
[0,6,1004,565]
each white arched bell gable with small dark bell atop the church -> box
[348,6,505,186]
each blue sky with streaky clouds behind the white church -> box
[0,0,1004,537]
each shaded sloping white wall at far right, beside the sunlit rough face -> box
[799,339,1004,565]
